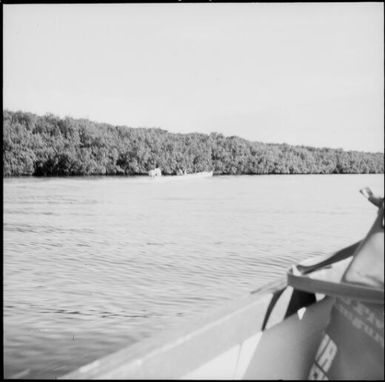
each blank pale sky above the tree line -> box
[3,2,384,152]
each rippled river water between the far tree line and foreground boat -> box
[3,175,384,378]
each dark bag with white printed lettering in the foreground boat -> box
[288,202,384,380]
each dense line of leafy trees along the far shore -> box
[3,111,384,176]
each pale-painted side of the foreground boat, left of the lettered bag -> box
[62,281,330,379]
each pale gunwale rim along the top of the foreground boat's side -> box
[59,278,287,379]
